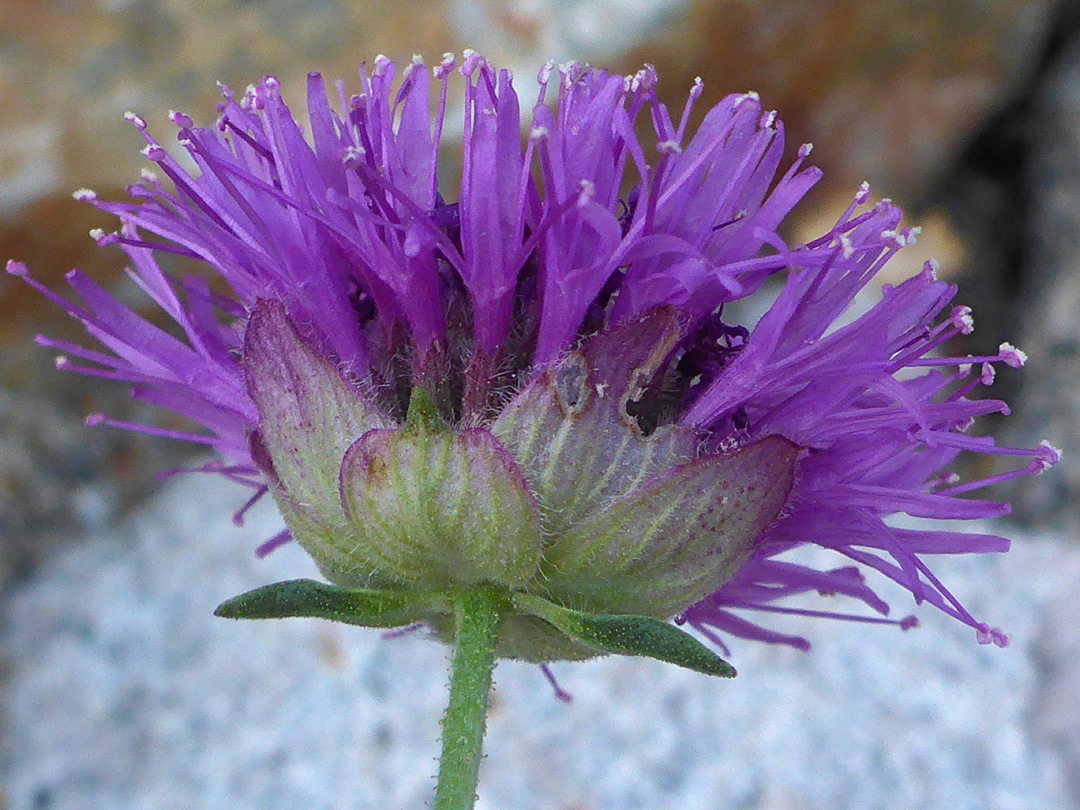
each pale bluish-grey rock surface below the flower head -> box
[0,477,1080,810]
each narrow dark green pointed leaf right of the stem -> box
[514,594,735,678]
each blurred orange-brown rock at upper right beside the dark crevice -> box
[622,0,1054,204]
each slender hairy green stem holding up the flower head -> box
[434,586,510,810]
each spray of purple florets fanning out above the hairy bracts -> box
[9,52,1059,647]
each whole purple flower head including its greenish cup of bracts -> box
[9,52,1058,661]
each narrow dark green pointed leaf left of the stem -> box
[214,579,453,627]
